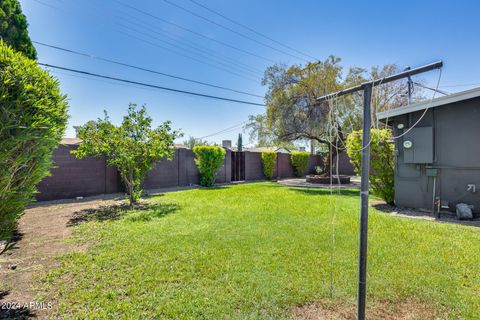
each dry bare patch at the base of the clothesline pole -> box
[292,301,437,320]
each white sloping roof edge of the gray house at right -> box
[377,87,480,120]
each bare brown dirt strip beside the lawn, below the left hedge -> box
[0,195,122,319]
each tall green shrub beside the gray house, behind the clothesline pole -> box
[347,129,395,204]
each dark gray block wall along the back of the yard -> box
[37,145,322,201]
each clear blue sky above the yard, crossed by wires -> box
[21,0,480,142]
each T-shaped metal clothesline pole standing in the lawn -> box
[317,61,443,320]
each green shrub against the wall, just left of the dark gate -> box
[193,146,225,187]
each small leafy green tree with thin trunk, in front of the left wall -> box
[72,104,180,206]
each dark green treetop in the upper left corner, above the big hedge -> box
[0,0,37,59]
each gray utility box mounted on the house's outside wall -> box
[402,127,433,163]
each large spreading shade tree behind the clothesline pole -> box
[246,56,421,170]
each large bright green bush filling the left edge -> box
[0,40,68,239]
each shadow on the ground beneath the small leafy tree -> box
[67,203,179,227]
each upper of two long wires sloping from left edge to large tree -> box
[32,41,263,98]
